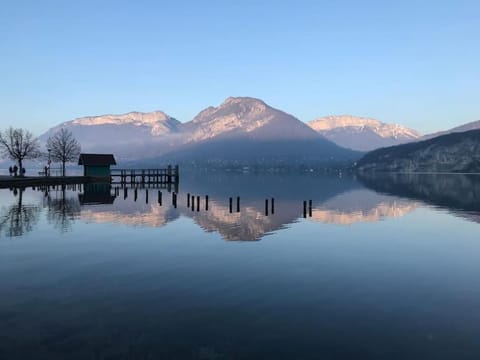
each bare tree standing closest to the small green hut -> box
[47,128,81,176]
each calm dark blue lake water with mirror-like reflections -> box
[0,172,480,360]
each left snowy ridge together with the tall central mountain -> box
[41,97,360,165]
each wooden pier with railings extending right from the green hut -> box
[110,165,179,185]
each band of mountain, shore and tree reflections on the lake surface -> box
[0,173,480,241]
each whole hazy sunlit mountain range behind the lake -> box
[32,97,480,165]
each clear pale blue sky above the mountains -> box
[0,0,480,134]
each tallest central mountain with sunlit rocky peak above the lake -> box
[156,97,360,166]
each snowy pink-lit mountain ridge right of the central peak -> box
[308,115,421,151]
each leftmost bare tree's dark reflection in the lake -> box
[0,188,40,237]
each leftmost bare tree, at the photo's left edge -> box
[0,127,41,176]
